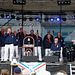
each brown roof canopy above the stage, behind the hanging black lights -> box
[0,0,75,11]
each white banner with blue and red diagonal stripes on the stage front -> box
[19,62,46,74]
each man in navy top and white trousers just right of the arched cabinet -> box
[34,33,42,61]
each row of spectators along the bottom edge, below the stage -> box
[1,67,67,75]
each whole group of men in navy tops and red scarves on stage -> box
[0,28,64,61]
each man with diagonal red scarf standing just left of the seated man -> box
[44,34,52,56]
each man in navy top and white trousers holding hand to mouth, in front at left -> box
[4,28,16,61]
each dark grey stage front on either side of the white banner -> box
[0,62,75,75]
